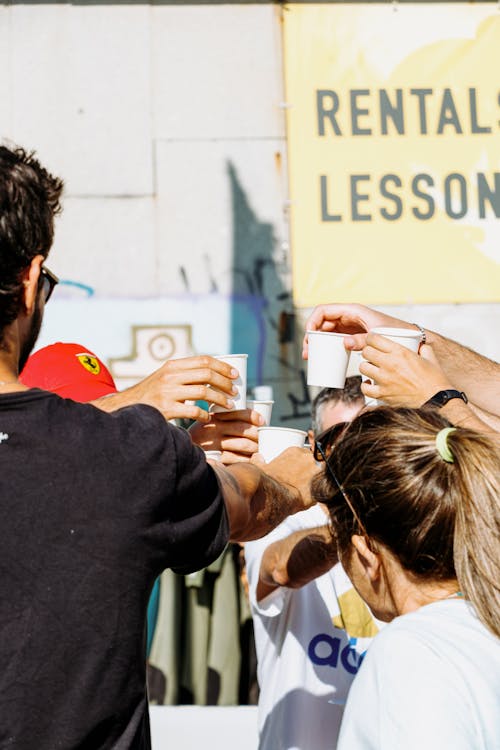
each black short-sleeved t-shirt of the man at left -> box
[0,390,228,750]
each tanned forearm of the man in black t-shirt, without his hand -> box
[212,463,311,542]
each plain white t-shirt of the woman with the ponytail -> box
[338,599,500,750]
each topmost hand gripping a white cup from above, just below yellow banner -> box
[302,303,411,359]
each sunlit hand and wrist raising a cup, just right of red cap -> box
[92,354,238,422]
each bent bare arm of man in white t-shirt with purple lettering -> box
[256,525,338,601]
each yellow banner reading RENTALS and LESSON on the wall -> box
[283,3,500,307]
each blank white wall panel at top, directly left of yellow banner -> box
[152,4,284,139]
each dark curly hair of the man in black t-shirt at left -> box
[0,146,63,342]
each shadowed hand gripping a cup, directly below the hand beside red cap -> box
[189,409,264,464]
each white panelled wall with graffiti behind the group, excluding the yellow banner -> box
[0,2,500,426]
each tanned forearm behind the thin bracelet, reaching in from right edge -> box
[427,331,500,416]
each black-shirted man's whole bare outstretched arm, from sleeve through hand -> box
[212,448,318,542]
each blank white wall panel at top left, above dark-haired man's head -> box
[2,4,153,195]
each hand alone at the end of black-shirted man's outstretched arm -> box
[252,448,321,510]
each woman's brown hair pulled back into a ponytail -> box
[313,407,500,636]
